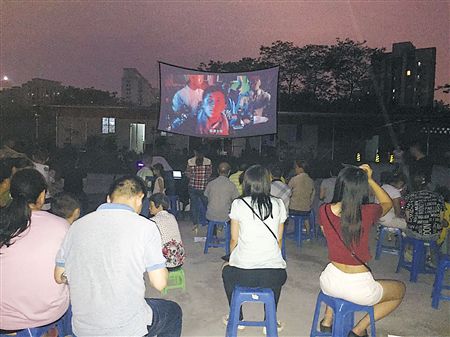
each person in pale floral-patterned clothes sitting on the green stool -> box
[150,193,185,271]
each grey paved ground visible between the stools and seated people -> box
[147,221,450,337]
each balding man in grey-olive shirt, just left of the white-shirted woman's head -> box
[204,162,239,221]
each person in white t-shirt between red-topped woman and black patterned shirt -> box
[376,172,406,229]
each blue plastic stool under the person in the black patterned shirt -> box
[396,237,439,282]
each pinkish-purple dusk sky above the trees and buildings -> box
[0,0,450,102]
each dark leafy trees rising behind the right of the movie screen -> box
[199,39,383,111]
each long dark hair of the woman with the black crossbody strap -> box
[242,165,272,220]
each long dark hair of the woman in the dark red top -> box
[331,167,369,247]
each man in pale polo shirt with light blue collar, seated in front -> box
[55,176,182,337]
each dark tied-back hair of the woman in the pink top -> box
[0,169,47,247]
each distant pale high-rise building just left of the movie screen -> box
[121,68,154,106]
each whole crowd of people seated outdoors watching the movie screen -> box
[0,142,450,337]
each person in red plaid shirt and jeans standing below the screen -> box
[186,148,212,230]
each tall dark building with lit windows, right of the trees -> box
[372,42,436,108]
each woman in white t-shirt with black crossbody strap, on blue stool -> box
[222,165,287,331]
